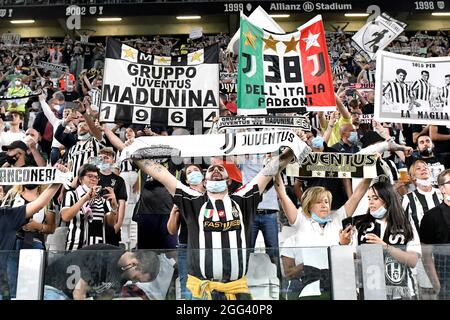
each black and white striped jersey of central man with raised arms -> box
[174,182,262,282]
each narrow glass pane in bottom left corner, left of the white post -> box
[0,251,19,300]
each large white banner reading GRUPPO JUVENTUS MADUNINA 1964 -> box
[100,38,219,127]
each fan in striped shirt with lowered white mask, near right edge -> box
[402,160,443,300]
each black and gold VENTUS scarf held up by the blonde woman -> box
[286,152,377,178]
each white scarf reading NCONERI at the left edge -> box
[0,167,73,185]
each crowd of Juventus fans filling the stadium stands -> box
[0,26,450,299]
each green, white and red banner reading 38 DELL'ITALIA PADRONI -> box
[238,15,336,115]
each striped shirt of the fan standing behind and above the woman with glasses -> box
[67,137,105,177]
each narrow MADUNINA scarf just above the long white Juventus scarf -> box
[217,116,311,131]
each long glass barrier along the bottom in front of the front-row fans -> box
[0,245,450,300]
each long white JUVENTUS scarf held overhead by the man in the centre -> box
[120,130,311,162]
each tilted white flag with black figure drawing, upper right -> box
[352,12,407,61]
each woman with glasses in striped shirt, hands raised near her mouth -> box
[61,164,118,251]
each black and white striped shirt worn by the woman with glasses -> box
[61,190,111,251]
